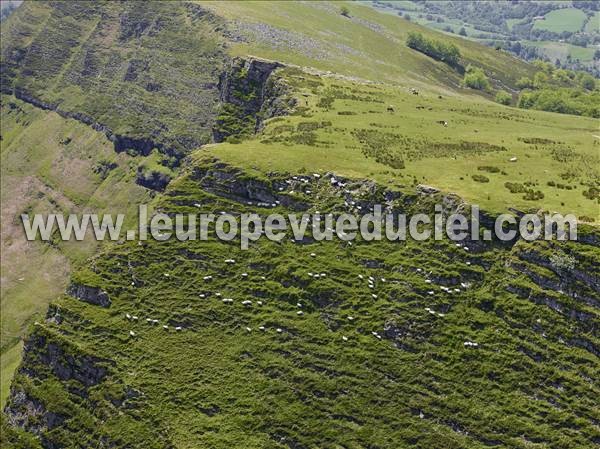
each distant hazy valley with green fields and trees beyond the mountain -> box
[372,0,600,77]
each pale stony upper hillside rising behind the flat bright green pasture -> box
[200,1,532,93]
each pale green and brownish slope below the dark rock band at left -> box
[0,96,148,403]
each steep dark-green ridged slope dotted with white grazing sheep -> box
[5,159,600,448]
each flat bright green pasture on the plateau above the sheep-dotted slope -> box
[207,68,599,219]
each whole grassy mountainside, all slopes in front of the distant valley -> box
[0,2,600,449]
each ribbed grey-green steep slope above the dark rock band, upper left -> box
[2,1,226,155]
